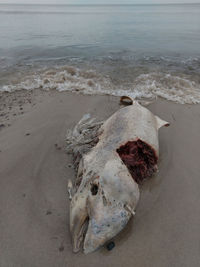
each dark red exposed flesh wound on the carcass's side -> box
[117,139,158,183]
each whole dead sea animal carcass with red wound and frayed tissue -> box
[67,101,169,253]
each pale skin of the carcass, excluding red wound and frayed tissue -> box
[70,101,168,253]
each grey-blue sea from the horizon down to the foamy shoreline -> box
[0,4,200,104]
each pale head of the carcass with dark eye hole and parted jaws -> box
[70,156,139,253]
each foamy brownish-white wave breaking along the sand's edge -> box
[0,66,200,104]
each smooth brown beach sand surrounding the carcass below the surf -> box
[0,90,200,267]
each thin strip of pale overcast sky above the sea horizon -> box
[0,0,200,4]
